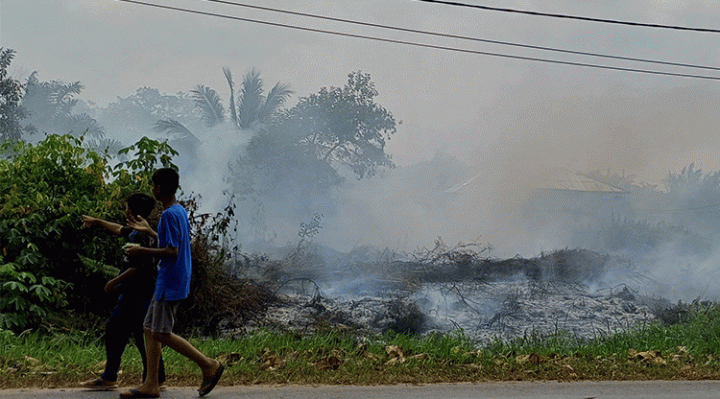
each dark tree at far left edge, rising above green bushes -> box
[0,47,27,141]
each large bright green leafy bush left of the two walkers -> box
[0,135,173,329]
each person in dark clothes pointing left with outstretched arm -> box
[81,193,165,390]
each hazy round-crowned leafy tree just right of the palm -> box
[232,71,396,222]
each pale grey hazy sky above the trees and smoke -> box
[5,0,720,186]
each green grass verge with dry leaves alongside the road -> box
[0,304,720,388]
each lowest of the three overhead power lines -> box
[115,0,720,80]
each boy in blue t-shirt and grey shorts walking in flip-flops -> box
[120,168,225,398]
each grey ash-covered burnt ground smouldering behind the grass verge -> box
[235,245,661,344]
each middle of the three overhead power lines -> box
[201,0,720,71]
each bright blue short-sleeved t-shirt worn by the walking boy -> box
[155,204,192,301]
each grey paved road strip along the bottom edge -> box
[0,381,720,399]
